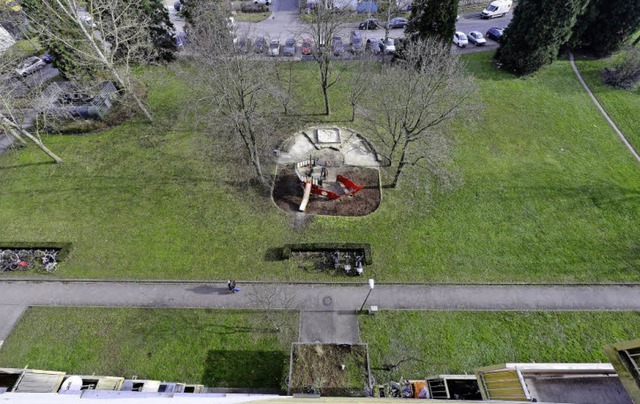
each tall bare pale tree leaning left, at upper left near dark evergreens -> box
[18,0,159,122]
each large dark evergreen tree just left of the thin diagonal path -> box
[495,0,586,74]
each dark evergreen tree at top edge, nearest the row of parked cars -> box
[406,0,458,42]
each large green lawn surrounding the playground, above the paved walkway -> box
[0,53,640,282]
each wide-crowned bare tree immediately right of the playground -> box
[365,39,475,188]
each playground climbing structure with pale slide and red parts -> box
[295,157,364,212]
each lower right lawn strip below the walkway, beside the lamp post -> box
[359,311,640,383]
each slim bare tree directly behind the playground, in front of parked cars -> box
[307,0,347,115]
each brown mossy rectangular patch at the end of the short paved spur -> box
[289,344,370,397]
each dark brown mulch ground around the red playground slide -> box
[273,166,380,216]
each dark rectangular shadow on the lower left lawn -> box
[201,350,287,389]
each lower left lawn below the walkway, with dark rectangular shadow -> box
[0,307,298,389]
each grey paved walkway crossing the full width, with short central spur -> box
[0,281,640,342]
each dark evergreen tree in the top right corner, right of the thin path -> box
[569,0,640,57]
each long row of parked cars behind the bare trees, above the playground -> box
[236,31,396,57]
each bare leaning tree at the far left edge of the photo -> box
[0,52,62,163]
